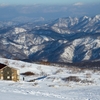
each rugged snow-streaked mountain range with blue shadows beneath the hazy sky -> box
[0,15,100,62]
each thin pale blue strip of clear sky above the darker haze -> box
[0,0,100,5]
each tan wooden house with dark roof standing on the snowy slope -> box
[0,63,19,82]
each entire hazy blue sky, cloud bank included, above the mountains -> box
[0,0,100,21]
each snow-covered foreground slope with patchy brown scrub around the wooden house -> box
[0,58,100,100]
